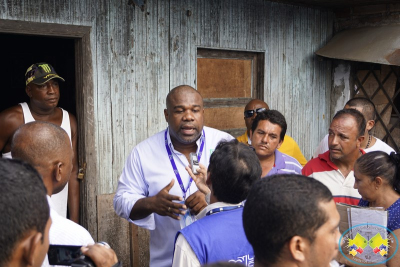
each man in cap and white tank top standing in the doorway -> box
[0,62,80,223]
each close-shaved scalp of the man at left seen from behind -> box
[11,121,73,172]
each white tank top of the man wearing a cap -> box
[3,102,72,218]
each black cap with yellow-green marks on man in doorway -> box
[25,62,65,85]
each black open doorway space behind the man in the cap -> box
[0,34,76,115]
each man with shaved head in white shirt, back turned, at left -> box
[11,121,94,266]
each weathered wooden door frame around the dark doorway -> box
[0,19,97,237]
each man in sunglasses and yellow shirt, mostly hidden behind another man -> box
[237,99,307,167]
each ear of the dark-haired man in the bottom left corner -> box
[20,231,43,266]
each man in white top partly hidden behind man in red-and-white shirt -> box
[313,97,394,158]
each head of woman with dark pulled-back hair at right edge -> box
[354,151,400,200]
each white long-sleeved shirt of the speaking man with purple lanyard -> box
[114,127,233,267]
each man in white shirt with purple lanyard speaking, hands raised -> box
[114,85,233,267]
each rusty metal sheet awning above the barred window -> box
[316,25,400,66]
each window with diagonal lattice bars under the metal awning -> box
[352,63,400,152]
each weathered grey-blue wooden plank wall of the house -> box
[0,0,333,266]
